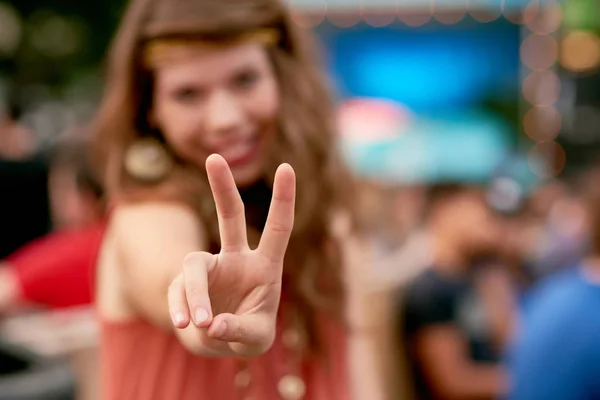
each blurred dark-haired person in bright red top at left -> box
[0,139,104,313]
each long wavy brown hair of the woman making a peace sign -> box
[93,0,353,350]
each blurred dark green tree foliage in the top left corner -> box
[0,0,125,104]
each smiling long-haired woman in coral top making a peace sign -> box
[95,0,382,400]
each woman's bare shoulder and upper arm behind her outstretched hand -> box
[99,202,205,329]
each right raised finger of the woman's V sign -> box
[258,164,296,263]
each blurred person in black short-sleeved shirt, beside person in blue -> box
[399,183,509,400]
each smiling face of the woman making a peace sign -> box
[150,43,279,186]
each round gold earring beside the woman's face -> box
[125,138,173,182]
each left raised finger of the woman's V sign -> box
[206,154,248,251]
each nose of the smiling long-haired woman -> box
[205,90,244,136]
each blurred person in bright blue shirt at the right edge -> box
[507,180,600,400]
